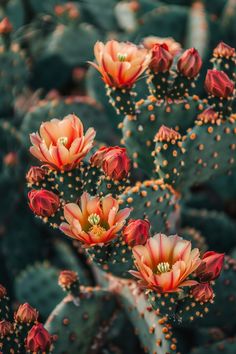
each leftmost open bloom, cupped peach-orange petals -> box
[30,114,96,170]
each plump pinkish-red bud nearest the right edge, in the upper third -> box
[205,69,234,98]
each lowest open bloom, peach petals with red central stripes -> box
[130,234,201,293]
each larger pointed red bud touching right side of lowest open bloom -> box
[197,251,224,282]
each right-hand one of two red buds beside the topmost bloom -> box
[177,48,202,78]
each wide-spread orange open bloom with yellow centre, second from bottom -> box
[60,192,131,247]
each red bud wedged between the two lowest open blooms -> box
[123,219,150,247]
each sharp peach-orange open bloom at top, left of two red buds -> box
[90,40,151,88]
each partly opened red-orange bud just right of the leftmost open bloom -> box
[91,146,130,180]
